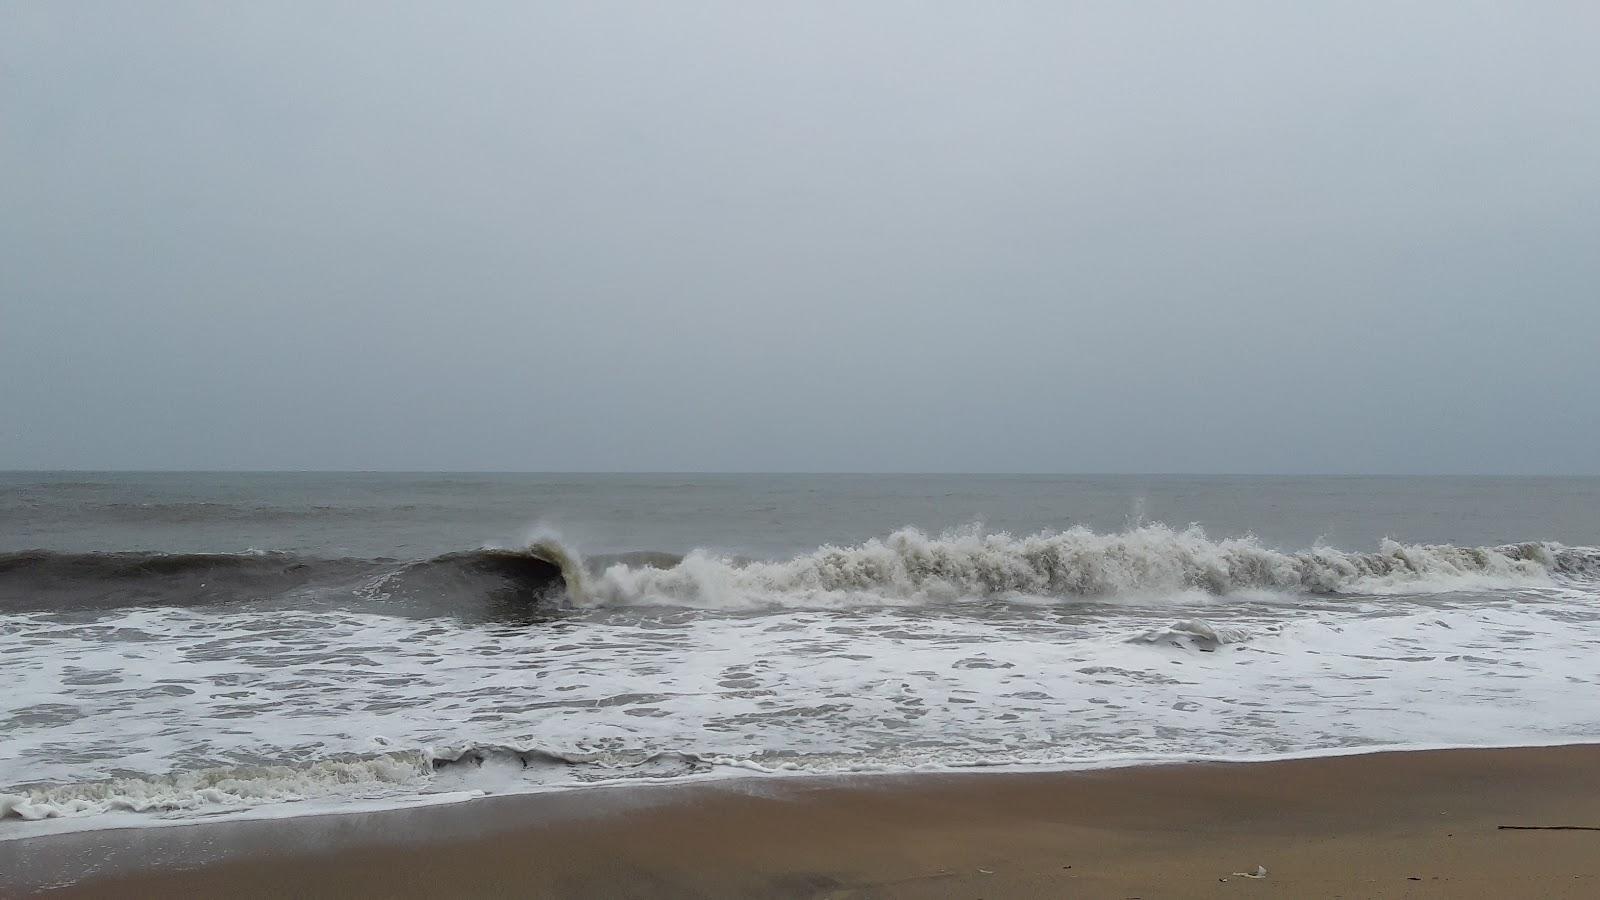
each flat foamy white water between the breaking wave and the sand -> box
[0,573,1600,839]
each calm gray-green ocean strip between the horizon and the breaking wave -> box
[9,472,1600,557]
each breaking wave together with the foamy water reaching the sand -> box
[0,512,1600,839]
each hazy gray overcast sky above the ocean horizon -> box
[0,0,1600,472]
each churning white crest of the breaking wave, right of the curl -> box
[576,525,1562,609]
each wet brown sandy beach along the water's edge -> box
[9,745,1600,900]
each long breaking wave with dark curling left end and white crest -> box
[0,525,1600,620]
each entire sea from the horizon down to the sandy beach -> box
[0,472,1600,841]
